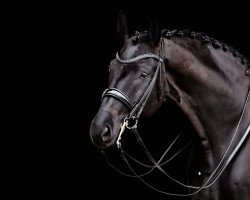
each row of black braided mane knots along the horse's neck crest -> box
[161,29,250,76]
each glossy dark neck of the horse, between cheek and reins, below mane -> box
[164,38,250,156]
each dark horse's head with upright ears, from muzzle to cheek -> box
[90,13,167,148]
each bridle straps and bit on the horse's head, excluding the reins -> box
[102,40,163,148]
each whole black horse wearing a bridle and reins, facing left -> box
[90,11,250,200]
